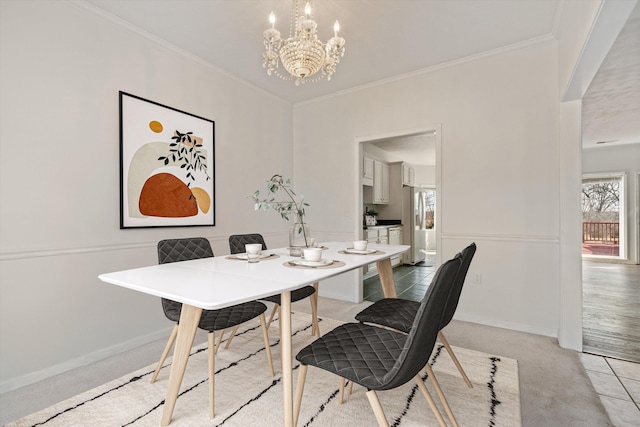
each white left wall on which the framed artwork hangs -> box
[0,1,292,391]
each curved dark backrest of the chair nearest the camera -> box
[379,254,462,390]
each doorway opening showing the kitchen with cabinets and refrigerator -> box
[357,125,441,301]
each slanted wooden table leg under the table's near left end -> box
[160,304,202,426]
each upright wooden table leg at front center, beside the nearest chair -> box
[280,292,293,427]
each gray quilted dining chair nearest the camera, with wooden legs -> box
[293,256,461,426]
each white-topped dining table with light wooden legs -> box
[98,242,410,427]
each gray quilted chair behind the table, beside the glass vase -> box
[227,233,320,338]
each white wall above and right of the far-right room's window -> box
[582,143,640,264]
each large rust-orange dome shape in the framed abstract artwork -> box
[138,173,198,218]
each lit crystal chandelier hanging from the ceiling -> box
[262,0,344,86]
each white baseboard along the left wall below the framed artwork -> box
[0,326,173,394]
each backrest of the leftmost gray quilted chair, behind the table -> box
[158,237,213,322]
